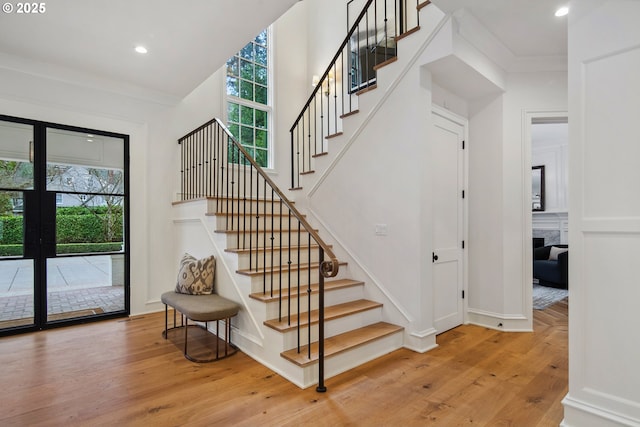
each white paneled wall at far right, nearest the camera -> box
[562,0,640,427]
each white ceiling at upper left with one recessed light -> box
[0,0,298,101]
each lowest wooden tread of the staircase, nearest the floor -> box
[280,322,404,367]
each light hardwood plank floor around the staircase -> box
[0,302,568,427]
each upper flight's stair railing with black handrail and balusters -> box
[290,0,430,189]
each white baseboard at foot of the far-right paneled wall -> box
[560,395,640,427]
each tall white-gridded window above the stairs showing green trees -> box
[226,29,272,167]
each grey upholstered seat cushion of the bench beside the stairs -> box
[160,291,240,322]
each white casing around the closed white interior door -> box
[431,104,470,333]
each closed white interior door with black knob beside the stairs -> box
[431,112,465,333]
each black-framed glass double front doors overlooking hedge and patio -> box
[0,115,129,334]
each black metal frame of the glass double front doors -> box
[0,114,131,336]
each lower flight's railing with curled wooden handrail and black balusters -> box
[178,119,338,391]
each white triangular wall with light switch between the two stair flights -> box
[310,59,432,330]
